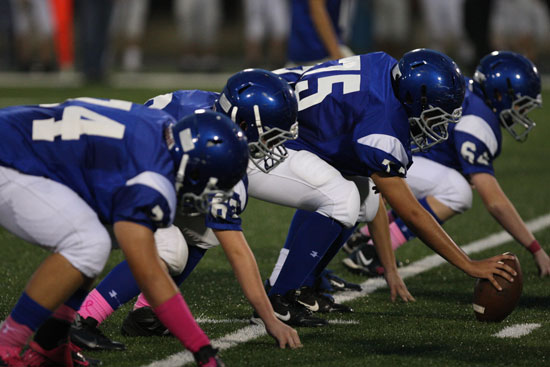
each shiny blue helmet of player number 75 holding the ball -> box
[392,48,466,152]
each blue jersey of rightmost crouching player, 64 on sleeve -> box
[415,80,502,176]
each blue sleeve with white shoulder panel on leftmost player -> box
[112,172,176,231]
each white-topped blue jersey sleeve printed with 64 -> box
[454,115,498,175]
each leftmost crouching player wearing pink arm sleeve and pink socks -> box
[0,98,248,367]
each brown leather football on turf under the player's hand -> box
[473,253,523,322]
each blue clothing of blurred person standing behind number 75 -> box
[288,0,342,64]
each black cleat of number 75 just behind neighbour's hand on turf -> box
[250,290,328,327]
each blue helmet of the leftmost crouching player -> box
[165,110,248,214]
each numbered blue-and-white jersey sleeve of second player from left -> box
[205,181,247,231]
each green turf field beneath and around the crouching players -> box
[0,87,550,367]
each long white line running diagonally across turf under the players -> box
[143,214,550,367]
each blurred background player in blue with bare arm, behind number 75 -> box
[287,0,353,66]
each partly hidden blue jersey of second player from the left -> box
[145,90,248,231]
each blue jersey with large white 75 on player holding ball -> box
[276,52,412,177]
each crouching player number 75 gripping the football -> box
[248,49,514,324]
